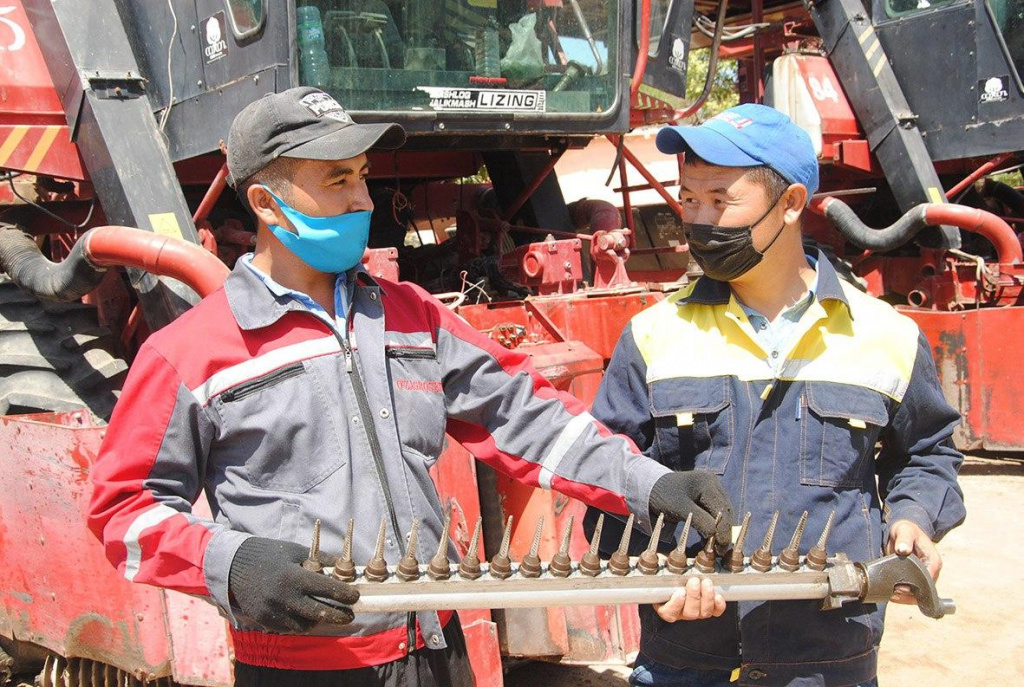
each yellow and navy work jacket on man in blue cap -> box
[593,254,965,685]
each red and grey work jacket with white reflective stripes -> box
[89,264,669,670]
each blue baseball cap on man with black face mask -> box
[654,102,818,203]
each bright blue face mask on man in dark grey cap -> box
[263,186,372,274]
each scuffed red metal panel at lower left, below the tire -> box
[0,412,171,677]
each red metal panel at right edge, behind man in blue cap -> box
[902,307,1024,450]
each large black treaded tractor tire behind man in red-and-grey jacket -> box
[0,273,128,422]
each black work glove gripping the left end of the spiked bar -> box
[227,536,359,634]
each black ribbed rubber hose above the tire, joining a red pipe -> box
[0,224,106,301]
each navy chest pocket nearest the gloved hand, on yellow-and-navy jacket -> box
[650,377,736,475]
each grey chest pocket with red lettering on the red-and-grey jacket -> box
[384,346,446,462]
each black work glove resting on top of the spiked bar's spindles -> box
[650,470,732,547]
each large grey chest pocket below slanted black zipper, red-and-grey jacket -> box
[214,362,347,493]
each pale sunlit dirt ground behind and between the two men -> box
[505,457,1024,687]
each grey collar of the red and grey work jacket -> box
[224,260,382,331]
